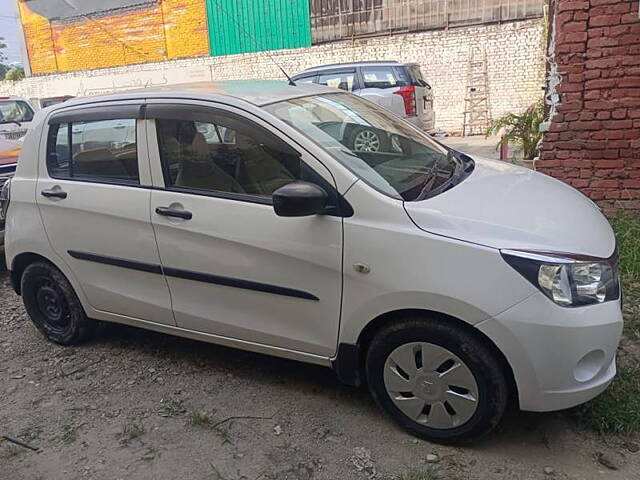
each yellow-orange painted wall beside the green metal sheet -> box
[20,0,209,75]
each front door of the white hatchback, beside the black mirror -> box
[146,103,342,356]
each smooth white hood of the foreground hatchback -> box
[404,158,615,258]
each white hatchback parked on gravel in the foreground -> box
[1,82,622,442]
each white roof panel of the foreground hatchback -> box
[48,80,336,111]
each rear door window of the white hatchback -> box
[47,118,140,185]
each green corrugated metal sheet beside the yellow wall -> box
[207,0,311,56]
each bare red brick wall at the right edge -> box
[537,0,640,210]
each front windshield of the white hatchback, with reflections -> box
[264,93,473,202]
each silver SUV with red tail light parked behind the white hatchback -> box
[292,61,435,138]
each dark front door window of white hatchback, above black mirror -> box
[156,111,328,201]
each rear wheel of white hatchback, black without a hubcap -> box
[21,262,96,345]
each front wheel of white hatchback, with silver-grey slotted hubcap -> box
[366,319,508,443]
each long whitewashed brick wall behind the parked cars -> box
[0,19,544,132]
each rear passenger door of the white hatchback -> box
[36,103,175,325]
